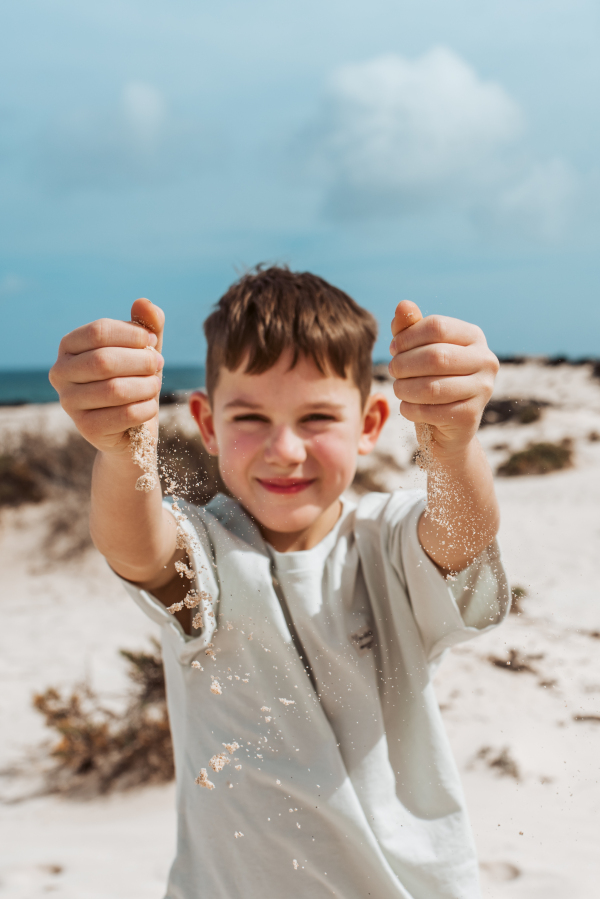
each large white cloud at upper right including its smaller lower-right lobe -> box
[310,48,577,239]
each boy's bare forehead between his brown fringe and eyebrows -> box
[215,350,360,405]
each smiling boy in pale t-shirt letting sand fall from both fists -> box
[51,267,509,899]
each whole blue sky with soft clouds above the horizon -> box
[0,0,600,368]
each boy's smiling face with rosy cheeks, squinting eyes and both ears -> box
[190,352,389,551]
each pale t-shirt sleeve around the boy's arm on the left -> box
[116,499,219,665]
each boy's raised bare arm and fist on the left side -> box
[50,300,185,604]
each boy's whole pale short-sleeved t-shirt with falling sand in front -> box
[118,491,510,899]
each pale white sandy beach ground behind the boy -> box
[0,360,600,899]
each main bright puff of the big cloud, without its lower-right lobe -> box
[315,48,522,214]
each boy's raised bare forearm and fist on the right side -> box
[389,300,500,574]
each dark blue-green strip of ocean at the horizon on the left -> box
[0,364,204,406]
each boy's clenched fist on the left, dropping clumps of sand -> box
[49,299,165,453]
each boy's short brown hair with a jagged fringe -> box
[204,266,377,405]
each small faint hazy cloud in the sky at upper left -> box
[35,81,210,190]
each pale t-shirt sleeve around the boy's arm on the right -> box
[390,491,511,662]
